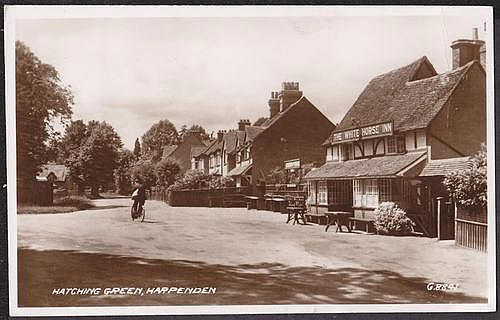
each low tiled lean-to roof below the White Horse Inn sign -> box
[305,151,426,179]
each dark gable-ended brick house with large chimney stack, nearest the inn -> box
[227,82,335,186]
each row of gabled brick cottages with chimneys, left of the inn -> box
[192,82,335,187]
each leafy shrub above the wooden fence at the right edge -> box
[443,144,487,211]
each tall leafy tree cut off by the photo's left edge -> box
[16,41,73,185]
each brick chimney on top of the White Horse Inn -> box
[451,28,486,69]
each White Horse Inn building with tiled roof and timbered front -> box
[306,34,486,238]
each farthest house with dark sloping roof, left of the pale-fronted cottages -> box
[162,130,209,175]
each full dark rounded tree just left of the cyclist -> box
[66,121,123,197]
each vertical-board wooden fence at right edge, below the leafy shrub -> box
[455,207,488,251]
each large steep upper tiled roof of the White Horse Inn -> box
[327,57,477,141]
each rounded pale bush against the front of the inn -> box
[373,202,415,235]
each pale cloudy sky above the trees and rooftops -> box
[16,10,486,149]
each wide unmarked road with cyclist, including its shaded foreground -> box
[17,198,487,306]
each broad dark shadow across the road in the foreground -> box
[18,249,487,307]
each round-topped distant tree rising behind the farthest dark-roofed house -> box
[141,120,178,163]
